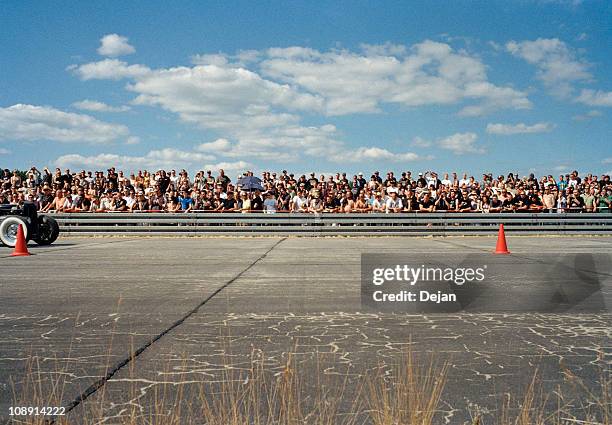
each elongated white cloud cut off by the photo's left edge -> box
[0,104,129,143]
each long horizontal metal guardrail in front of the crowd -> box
[50,213,612,236]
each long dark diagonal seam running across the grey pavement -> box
[46,237,287,425]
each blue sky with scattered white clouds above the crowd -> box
[0,0,612,175]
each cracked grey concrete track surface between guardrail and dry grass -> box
[0,237,612,424]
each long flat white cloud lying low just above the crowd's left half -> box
[55,148,215,171]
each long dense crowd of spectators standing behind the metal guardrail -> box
[0,167,612,213]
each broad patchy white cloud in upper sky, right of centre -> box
[260,40,531,115]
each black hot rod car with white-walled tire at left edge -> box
[0,202,59,247]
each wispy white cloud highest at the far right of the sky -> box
[506,38,591,97]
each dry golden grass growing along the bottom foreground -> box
[7,342,612,425]
